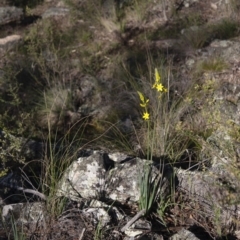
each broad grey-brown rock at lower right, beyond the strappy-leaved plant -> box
[176,167,240,234]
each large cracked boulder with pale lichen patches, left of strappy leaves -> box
[58,151,172,204]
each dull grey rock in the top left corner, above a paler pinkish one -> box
[0,7,23,26]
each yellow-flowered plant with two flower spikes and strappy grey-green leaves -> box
[138,68,170,217]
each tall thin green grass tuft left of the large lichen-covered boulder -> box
[40,128,80,220]
